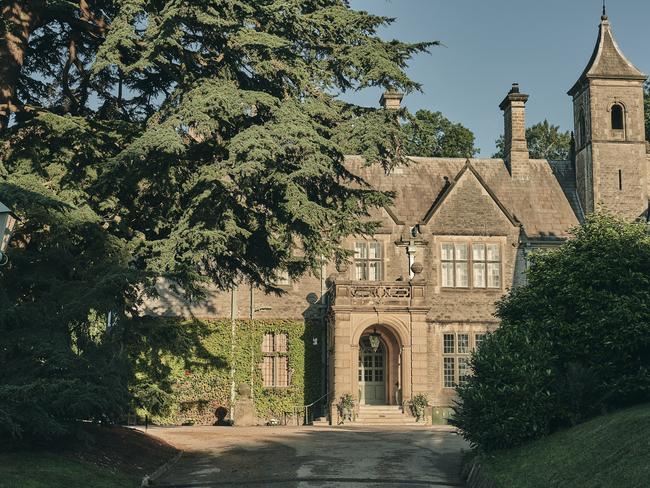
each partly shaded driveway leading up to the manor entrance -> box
[149,427,467,488]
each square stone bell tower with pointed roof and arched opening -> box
[568,9,649,219]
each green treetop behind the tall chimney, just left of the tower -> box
[492,120,571,161]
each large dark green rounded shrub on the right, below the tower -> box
[454,213,650,450]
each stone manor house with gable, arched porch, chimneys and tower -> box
[148,15,650,423]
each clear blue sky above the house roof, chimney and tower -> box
[345,0,650,157]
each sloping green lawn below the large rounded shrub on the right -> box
[484,404,650,488]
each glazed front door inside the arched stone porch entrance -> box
[359,339,386,405]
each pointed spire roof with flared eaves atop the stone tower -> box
[568,15,648,96]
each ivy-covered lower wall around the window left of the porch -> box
[133,318,324,424]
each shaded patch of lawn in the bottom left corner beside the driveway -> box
[0,451,142,488]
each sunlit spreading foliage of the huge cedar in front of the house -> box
[0,0,435,296]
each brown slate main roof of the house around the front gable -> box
[346,156,582,239]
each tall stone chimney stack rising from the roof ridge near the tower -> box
[499,83,529,178]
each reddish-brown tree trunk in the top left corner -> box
[0,0,38,134]
